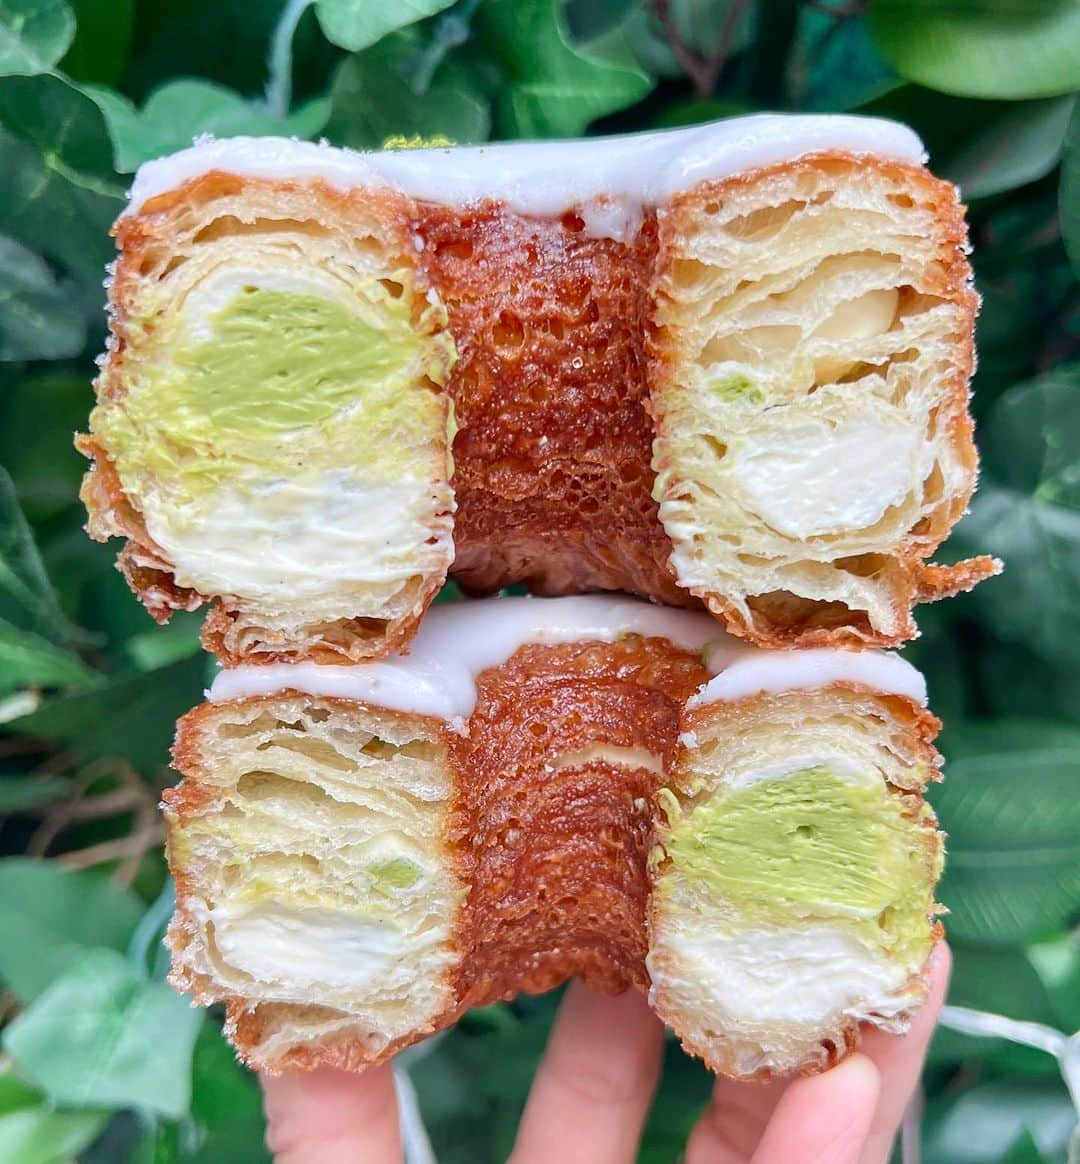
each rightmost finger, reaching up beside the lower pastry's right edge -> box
[860,942,952,1164]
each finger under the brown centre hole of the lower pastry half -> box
[511,981,663,1164]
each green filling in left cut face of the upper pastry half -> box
[94,280,452,496]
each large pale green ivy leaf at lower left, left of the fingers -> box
[3,950,203,1120]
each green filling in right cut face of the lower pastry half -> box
[661,767,935,960]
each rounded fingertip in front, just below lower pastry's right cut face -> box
[752,1055,881,1164]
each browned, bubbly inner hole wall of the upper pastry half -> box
[418,203,698,606]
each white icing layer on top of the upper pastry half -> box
[127,113,925,240]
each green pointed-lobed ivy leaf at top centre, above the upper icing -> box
[477,0,653,137]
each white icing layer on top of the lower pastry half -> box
[207,595,926,726]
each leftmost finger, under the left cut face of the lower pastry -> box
[261,1063,402,1164]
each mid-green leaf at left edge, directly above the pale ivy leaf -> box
[0,857,143,1002]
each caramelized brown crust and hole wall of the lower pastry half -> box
[164,639,940,1078]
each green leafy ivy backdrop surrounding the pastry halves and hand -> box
[0,0,1080,1164]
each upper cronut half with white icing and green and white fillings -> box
[80,115,994,662]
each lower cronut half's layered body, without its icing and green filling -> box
[165,637,942,1077]
